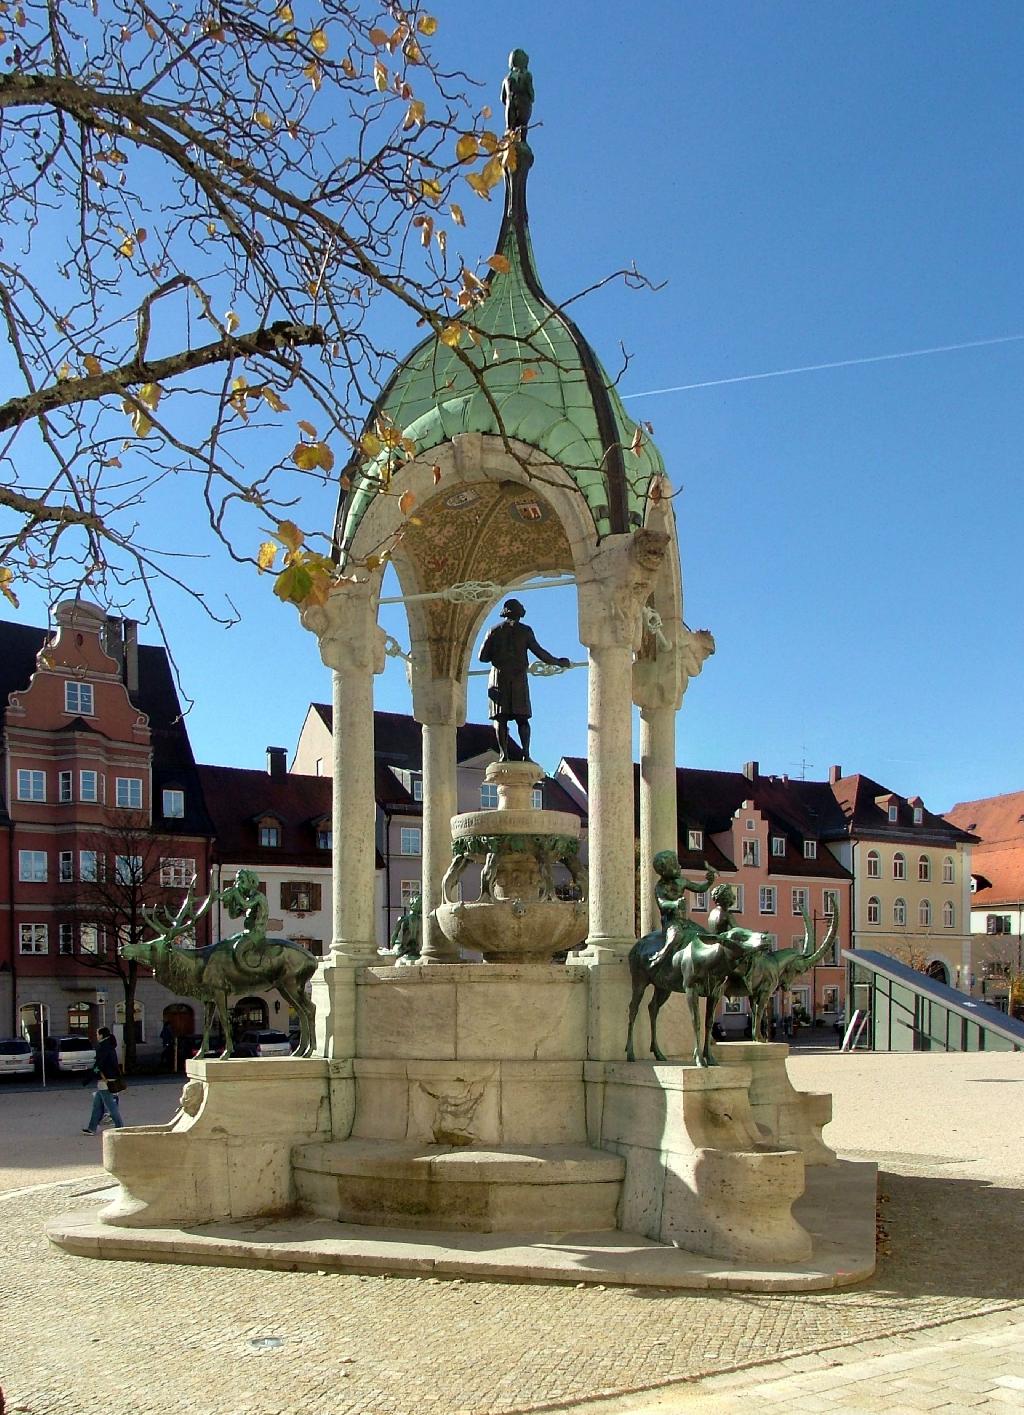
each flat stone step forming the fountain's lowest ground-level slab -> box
[47,1160,875,1292]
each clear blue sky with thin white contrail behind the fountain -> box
[9,0,1024,809]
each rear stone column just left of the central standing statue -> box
[413,669,465,964]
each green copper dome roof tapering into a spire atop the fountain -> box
[337,59,663,555]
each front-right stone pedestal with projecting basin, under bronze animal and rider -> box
[586,1061,810,1262]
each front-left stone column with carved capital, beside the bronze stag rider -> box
[303,584,385,1058]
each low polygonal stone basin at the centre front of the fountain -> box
[291,1139,625,1234]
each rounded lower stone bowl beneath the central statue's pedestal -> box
[436,899,588,964]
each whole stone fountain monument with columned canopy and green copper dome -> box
[51,51,874,1290]
